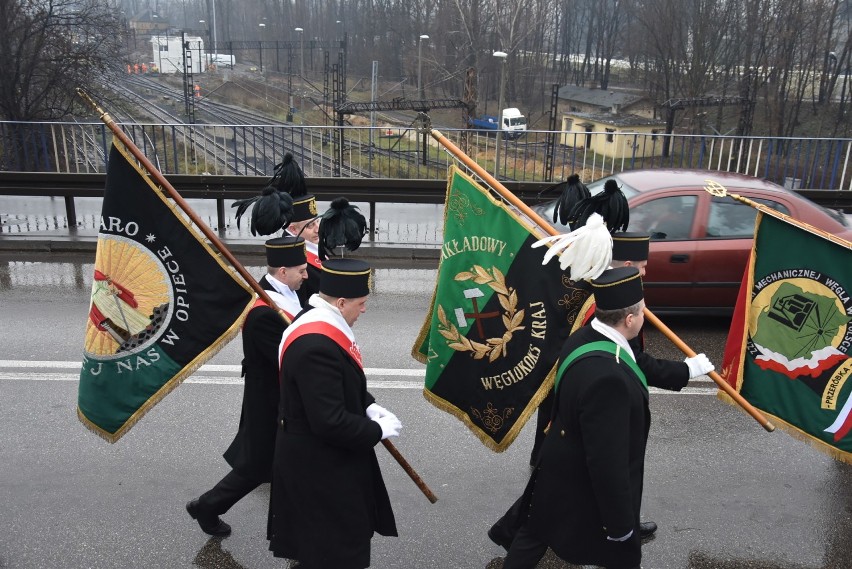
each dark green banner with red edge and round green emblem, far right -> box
[723,213,852,462]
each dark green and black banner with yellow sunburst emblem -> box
[77,141,253,442]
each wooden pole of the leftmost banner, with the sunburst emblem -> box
[77,88,438,504]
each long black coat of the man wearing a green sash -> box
[525,326,651,569]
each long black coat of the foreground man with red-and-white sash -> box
[267,309,397,569]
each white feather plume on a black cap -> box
[532,213,612,281]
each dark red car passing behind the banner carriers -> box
[533,169,852,314]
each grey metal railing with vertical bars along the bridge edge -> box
[5,122,852,191]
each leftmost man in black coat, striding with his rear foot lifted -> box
[186,237,307,536]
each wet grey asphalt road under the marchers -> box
[0,253,852,569]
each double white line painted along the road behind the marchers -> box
[0,360,716,395]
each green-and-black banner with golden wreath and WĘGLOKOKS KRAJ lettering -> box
[412,168,591,452]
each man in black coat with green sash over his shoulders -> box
[503,267,651,569]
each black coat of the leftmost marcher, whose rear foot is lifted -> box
[223,276,287,482]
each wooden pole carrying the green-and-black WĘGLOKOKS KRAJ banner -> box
[429,128,775,432]
